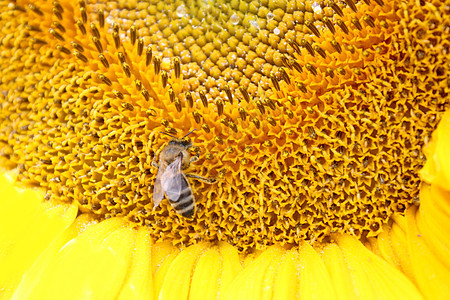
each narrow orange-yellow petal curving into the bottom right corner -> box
[406,206,450,299]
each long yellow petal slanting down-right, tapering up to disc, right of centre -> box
[336,235,422,299]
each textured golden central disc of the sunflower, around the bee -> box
[0,0,450,251]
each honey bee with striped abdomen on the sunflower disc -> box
[152,129,216,218]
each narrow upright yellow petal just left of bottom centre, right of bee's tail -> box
[189,247,222,300]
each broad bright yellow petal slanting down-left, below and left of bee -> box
[19,219,136,299]
